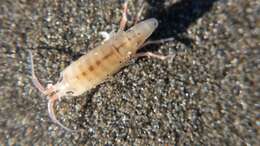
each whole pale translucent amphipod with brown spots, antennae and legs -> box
[30,17,171,131]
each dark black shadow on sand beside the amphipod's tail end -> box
[145,0,217,48]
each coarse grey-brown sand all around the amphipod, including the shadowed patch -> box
[0,0,260,145]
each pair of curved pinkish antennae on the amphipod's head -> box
[29,50,76,132]
